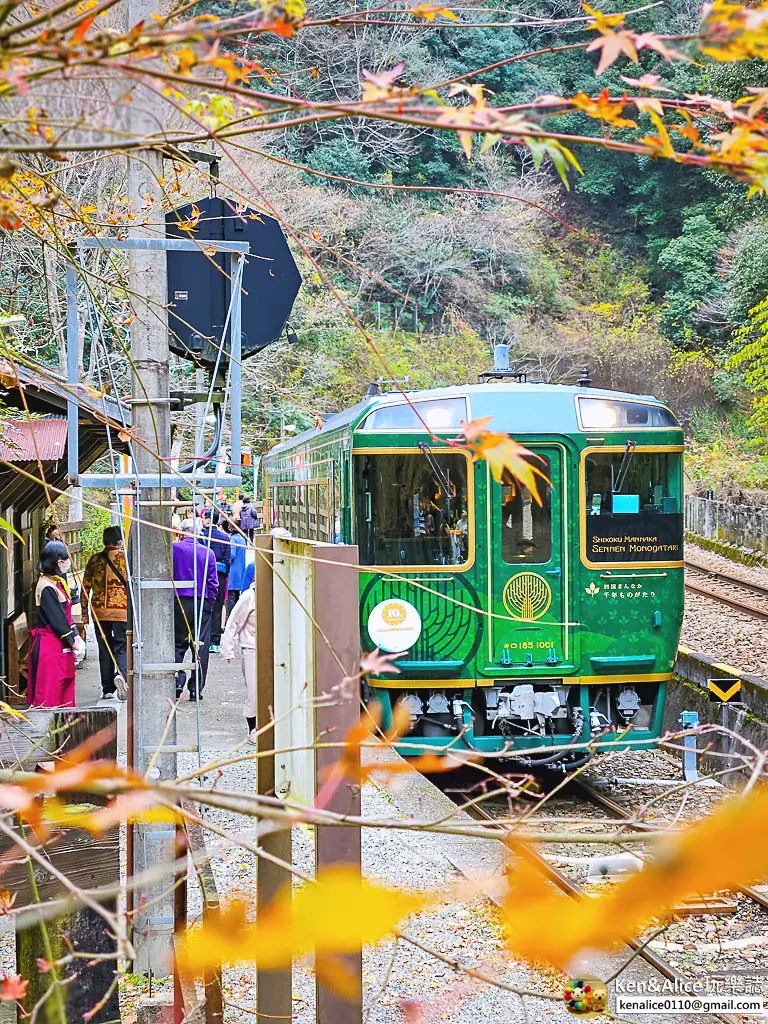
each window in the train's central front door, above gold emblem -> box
[501,458,552,565]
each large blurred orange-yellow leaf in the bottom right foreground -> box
[504,786,768,970]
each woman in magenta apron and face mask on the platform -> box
[28,541,85,708]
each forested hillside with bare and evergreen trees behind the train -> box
[0,0,768,495]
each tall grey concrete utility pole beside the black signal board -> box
[125,0,176,977]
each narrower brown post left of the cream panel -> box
[253,536,292,1021]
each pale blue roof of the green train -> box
[268,381,677,455]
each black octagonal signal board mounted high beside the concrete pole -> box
[166,197,301,367]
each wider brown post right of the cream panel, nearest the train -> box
[312,544,362,1024]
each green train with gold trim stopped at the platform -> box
[263,377,683,769]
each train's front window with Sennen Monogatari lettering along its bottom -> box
[583,442,683,563]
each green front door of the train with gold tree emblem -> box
[487,444,574,677]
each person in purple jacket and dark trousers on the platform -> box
[173,519,219,700]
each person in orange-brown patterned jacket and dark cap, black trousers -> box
[81,526,128,700]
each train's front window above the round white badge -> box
[354,456,469,565]
